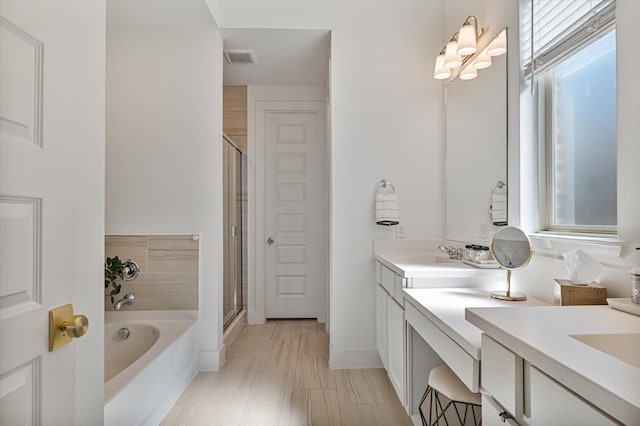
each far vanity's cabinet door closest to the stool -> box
[387,297,406,406]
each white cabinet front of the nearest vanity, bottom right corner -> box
[481,334,619,426]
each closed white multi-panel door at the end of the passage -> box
[258,102,329,318]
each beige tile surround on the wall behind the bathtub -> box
[105,234,199,311]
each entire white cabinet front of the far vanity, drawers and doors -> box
[376,262,406,407]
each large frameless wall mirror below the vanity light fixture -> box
[445,28,508,245]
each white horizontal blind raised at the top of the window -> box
[520,0,616,77]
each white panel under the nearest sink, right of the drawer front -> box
[531,368,617,426]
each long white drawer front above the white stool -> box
[405,303,480,392]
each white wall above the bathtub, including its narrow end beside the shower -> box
[106,1,224,369]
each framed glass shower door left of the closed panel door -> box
[222,134,247,328]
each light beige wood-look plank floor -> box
[162,320,412,426]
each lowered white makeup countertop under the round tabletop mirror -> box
[403,288,545,360]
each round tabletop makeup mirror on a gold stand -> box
[491,226,532,300]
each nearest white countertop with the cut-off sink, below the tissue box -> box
[466,306,640,425]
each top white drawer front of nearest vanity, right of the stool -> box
[481,334,524,418]
